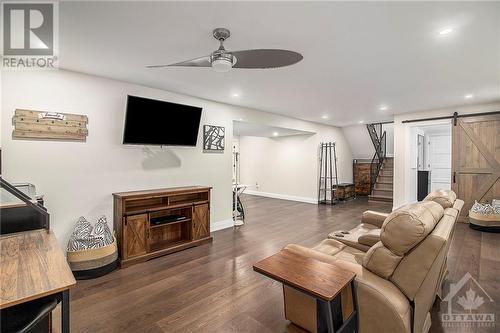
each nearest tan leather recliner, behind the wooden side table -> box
[284,197,458,333]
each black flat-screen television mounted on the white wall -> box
[123,96,201,146]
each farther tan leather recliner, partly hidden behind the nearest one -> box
[328,190,464,252]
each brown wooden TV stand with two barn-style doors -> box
[113,186,212,267]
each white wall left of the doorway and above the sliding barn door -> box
[393,103,500,208]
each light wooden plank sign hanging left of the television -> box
[12,109,88,141]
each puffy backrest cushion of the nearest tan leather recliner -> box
[363,201,444,279]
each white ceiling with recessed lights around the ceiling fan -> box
[59,1,500,126]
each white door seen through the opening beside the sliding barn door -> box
[428,135,451,191]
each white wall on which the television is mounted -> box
[1,70,351,244]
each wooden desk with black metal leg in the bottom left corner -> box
[0,229,76,332]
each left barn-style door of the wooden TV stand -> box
[123,214,148,259]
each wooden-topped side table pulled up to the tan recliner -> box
[253,250,358,333]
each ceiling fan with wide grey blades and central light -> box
[146,28,303,72]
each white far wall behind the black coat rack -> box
[240,124,352,203]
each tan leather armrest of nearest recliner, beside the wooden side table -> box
[285,244,412,333]
